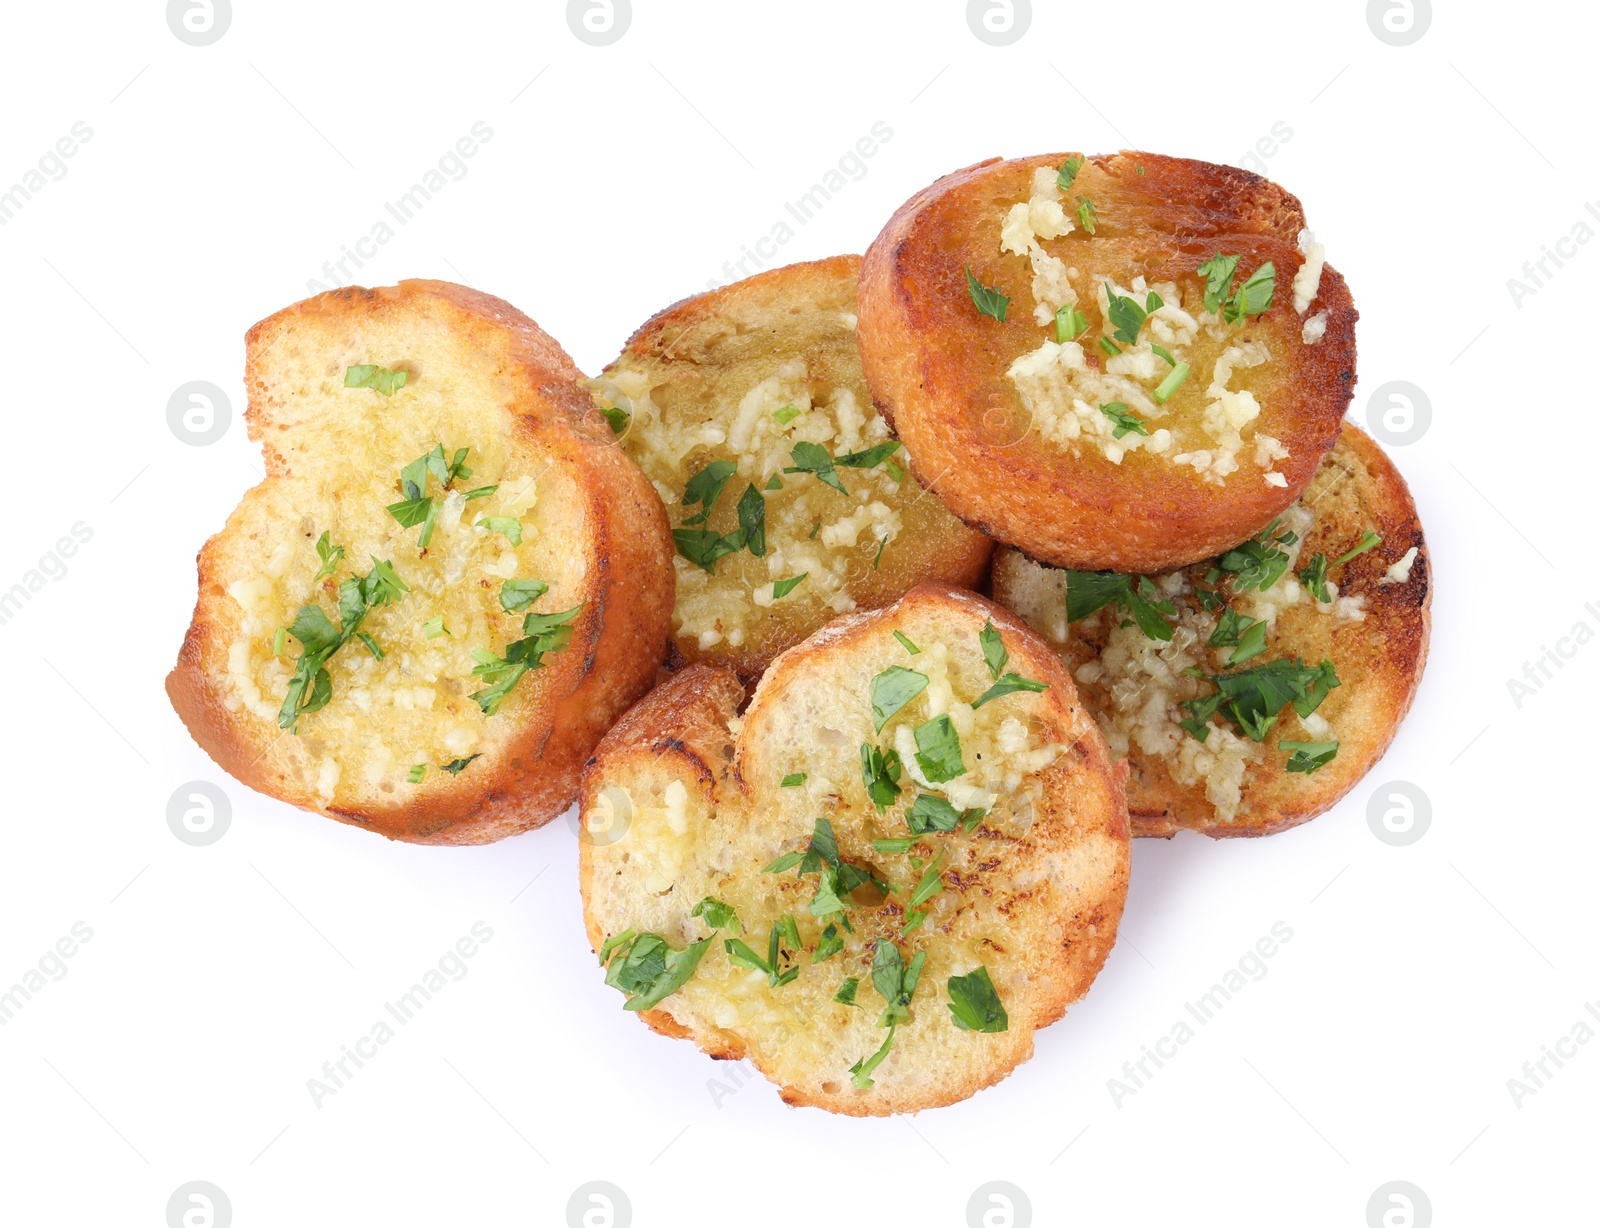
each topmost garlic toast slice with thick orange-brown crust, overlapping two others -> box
[859,154,1355,572]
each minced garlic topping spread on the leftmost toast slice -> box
[226,457,582,803]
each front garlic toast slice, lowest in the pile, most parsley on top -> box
[579,584,1128,1116]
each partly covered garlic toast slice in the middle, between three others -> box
[590,256,992,681]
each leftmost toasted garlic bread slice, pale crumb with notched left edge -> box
[166,281,672,844]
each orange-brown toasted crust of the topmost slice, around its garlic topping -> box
[859,152,1355,572]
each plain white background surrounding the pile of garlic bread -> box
[0,0,1600,1228]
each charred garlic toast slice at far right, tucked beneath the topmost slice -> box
[994,425,1432,836]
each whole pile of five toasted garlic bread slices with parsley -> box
[168,152,1430,1114]
